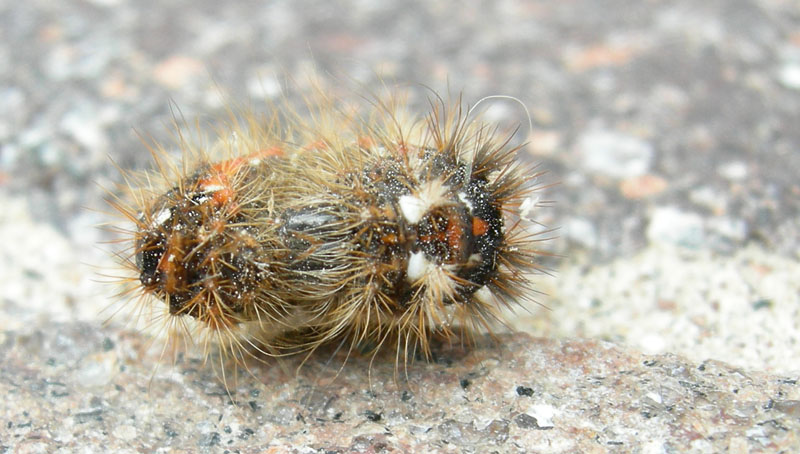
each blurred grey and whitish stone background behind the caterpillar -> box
[0,0,800,372]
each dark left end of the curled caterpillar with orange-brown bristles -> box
[135,163,269,328]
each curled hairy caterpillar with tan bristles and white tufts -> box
[111,88,543,372]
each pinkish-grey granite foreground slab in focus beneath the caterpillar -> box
[0,323,800,453]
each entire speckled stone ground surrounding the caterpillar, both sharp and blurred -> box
[0,0,800,453]
